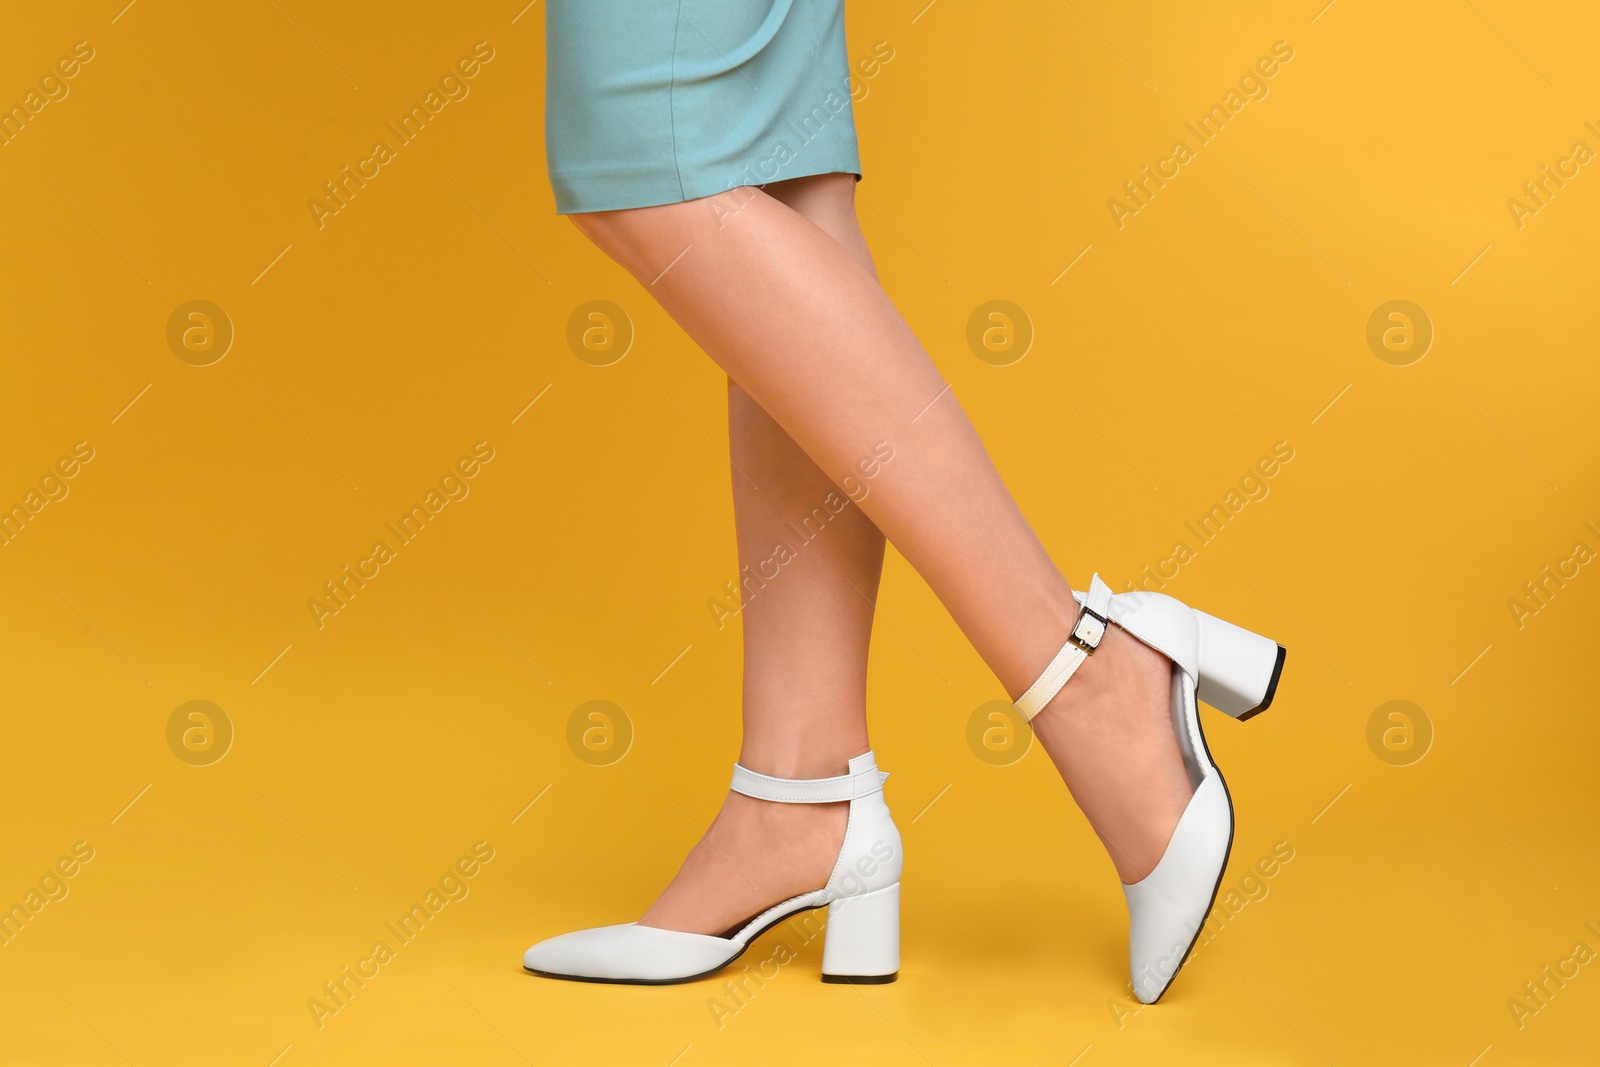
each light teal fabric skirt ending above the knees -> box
[544,0,861,214]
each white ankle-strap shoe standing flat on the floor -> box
[522,752,902,985]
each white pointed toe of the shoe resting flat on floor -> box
[522,923,744,982]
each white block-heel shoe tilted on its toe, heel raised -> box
[1016,574,1285,1005]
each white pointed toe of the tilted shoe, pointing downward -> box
[1122,774,1234,1005]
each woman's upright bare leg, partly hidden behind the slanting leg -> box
[640,178,883,934]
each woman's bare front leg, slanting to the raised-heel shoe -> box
[571,176,1192,881]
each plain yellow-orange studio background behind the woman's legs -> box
[0,0,1600,1067]
